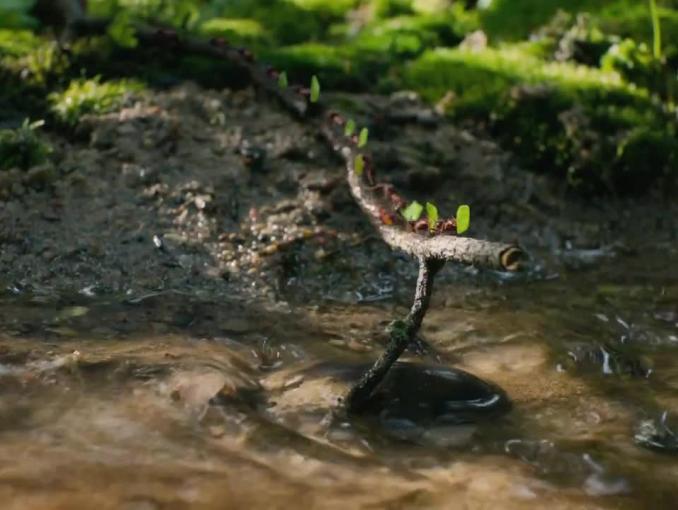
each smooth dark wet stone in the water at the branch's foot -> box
[365,362,511,427]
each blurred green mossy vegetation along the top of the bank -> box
[0,0,678,193]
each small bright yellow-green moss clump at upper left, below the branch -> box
[48,78,142,126]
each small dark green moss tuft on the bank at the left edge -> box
[0,119,52,170]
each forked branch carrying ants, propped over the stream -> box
[66,18,524,411]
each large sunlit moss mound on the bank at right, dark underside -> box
[403,46,678,192]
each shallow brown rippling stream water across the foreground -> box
[0,249,678,510]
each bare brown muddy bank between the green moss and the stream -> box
[0,81,678,301]
